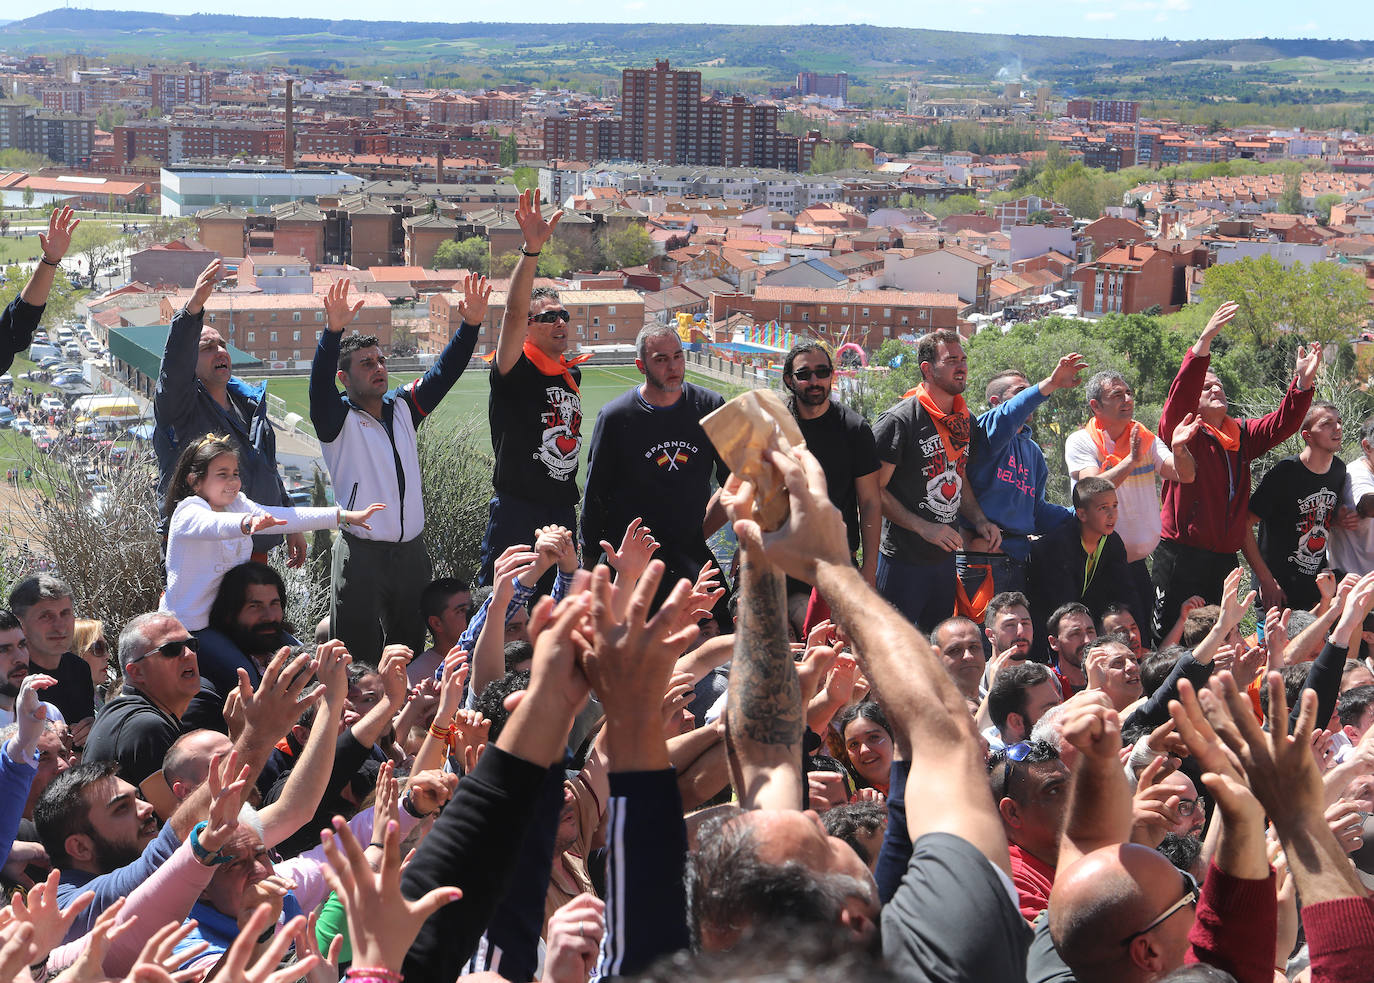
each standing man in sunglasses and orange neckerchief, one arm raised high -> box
[477,190,582,593]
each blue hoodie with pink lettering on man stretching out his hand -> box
[969,385,1073,561]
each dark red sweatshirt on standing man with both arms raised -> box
[1158,349,1312,553]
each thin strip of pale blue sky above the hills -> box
[3,0,1374,38]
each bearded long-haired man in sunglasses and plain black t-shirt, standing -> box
[782,341,882,587]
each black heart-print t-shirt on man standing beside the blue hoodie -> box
[872,396,980,564]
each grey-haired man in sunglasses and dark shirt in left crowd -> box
[84,612,201,785]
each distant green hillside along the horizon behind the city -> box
[8,10,1374,98]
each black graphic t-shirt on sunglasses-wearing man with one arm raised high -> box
[486,353,583,506]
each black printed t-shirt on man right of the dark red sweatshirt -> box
[1250,456,1345,610]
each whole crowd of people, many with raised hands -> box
[0,192,1374,983]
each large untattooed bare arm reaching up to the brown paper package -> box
[727,448,1010,872]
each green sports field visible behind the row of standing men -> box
[250,366,739,474]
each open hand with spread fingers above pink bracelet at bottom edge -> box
[317,817,463,979]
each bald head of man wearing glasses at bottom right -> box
[1050,843,1194,983]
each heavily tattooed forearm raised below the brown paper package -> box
[725,547,802,808]
